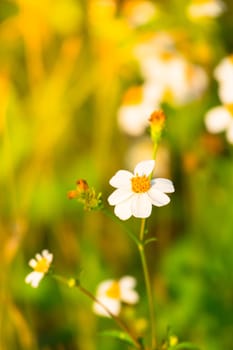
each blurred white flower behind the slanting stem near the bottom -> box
[93,276,139,317]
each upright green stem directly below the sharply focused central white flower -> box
[138,219,156,350]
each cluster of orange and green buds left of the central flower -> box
[68,179,102,211]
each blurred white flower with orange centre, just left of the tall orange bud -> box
[117,85,158,136]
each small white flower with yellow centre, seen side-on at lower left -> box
[25,249,53,288]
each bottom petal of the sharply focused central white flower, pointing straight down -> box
[131,193,152,218]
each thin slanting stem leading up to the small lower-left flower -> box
[52,275,144,350]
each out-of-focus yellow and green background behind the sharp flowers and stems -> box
[0,0,233,350]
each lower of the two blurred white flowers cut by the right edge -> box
[205,105,233,144]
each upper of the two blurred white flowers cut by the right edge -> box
[214,55,233,104]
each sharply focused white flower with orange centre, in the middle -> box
[108,160,174,220]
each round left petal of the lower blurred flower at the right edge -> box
[205,106,231,133]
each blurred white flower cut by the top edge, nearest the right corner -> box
[187,0,226,19]
